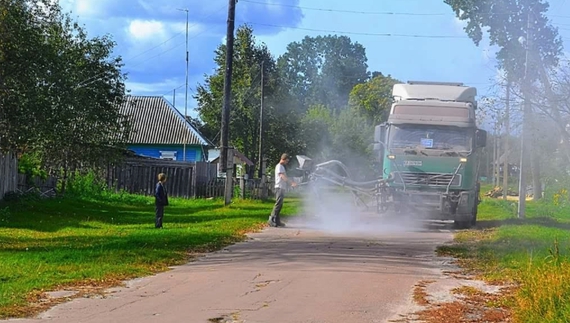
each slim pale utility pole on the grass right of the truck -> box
[517,9,531,219]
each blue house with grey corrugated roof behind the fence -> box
[120,95,215,162]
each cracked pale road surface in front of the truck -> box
[8,218,452,323]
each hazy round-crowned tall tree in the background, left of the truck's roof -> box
[278,35,369,113]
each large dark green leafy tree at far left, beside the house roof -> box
[0,0,129,186]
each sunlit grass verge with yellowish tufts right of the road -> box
[438,184,570,323]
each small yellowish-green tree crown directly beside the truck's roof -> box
[349,73,400,125]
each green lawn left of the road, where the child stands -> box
[0,194,298,318]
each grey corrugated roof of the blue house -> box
[120,95,215,146]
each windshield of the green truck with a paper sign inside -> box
[389,125,472,152]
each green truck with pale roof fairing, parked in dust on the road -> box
[374,82,487,228]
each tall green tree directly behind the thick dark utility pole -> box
[195,25,295,175]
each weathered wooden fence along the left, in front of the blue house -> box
[0,154,272,199]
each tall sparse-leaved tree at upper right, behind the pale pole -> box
[444,0,562,197]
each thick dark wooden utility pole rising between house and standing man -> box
[220,0,237,205]
